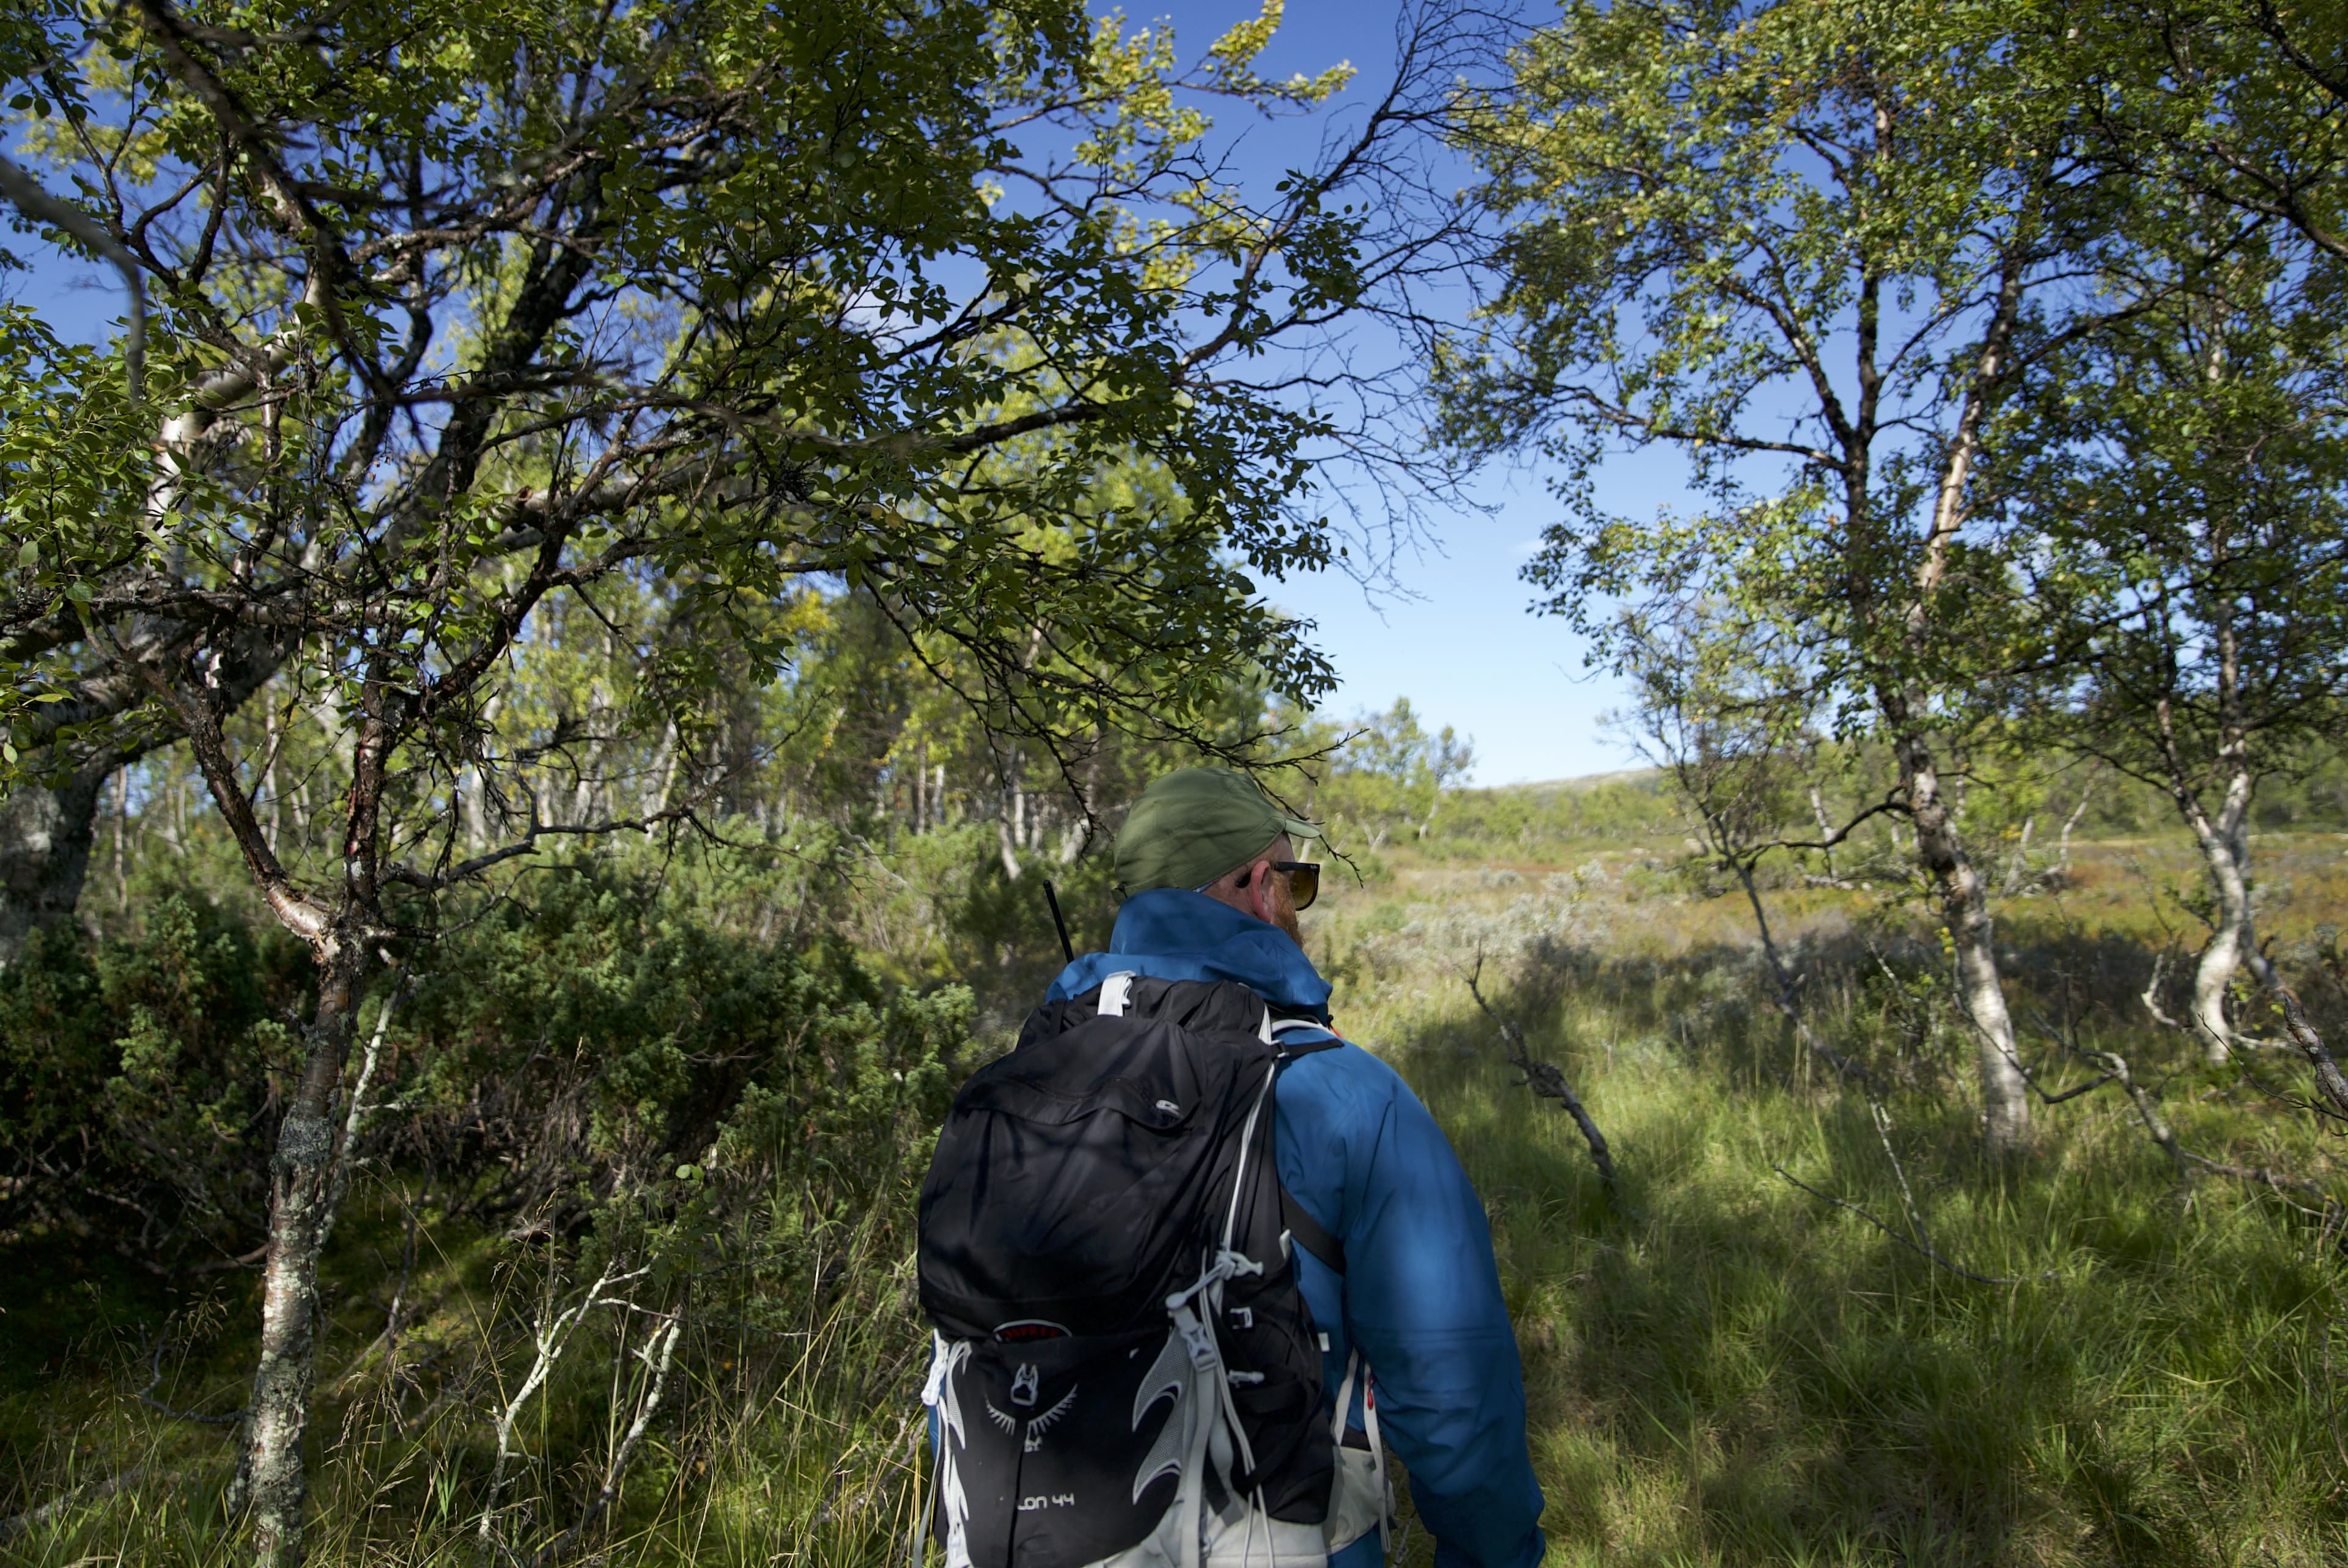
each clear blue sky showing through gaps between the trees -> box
[9,0,1679,784]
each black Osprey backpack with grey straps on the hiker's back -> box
[920,974,1343,1568]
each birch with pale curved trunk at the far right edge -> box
[1988,223,2348,1063]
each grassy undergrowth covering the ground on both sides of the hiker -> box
[0,833,2348,1568]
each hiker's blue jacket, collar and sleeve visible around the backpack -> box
[1052,887,1545,1568]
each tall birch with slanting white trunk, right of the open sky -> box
[1442,0,2160,1155]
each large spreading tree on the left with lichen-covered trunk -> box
[0,0,1483,1561]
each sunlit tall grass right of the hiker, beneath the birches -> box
[1322,847,2348,1563]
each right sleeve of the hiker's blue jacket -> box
[1282,1049,1545,1568]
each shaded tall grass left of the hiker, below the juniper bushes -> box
[0,1173,928,1568]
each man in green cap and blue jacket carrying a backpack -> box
[920,768,1545,1568]
